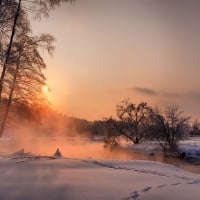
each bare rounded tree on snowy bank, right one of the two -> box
[149,105,190,152]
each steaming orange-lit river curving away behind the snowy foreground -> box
[0,138,200,174]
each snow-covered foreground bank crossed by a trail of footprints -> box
[0,155,200,200]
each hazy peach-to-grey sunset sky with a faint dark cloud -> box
[33,0,200,119]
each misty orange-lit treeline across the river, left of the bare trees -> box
[3,102,105,137]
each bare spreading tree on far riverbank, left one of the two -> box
[105,100,152,146]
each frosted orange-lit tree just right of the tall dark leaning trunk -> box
[0,32,54,136]
